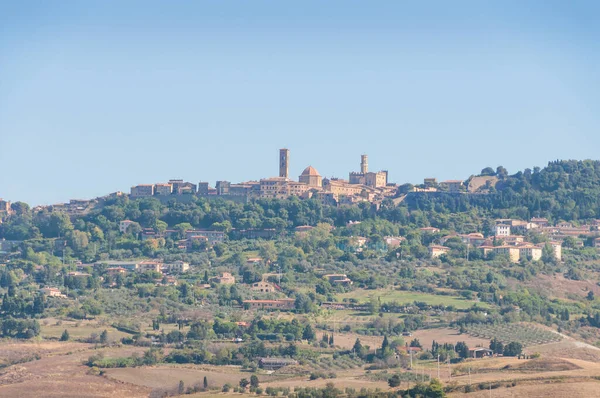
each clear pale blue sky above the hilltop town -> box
[0,0,600,204]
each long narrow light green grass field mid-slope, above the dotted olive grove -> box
[337,289,488,309]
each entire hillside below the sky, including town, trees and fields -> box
[0,157,600,397]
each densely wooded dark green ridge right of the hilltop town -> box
[404,160,600,221]
